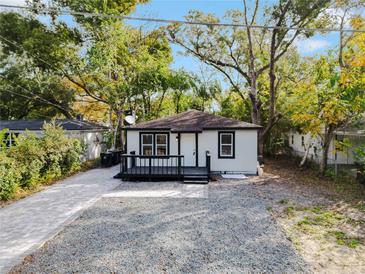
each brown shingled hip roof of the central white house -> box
[129,110,261,132]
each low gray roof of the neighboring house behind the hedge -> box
[0,119,108,131]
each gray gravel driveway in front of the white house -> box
[9,181,309,273]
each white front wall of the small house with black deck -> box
[127,130,257,174]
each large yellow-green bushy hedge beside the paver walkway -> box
[0,123,85,200]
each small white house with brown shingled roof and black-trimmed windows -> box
[125,110,261,182]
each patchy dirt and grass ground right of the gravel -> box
[258,158,365,273]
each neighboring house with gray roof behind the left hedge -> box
[0,120,108,160]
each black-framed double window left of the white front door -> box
[140,132,169,156]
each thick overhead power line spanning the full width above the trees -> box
[0,4,365,33]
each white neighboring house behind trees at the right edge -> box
[288,129,365,165]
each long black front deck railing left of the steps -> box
[120,152,184,179]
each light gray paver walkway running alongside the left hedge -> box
[0,166,120,273]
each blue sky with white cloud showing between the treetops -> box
[0,0,356,72]
